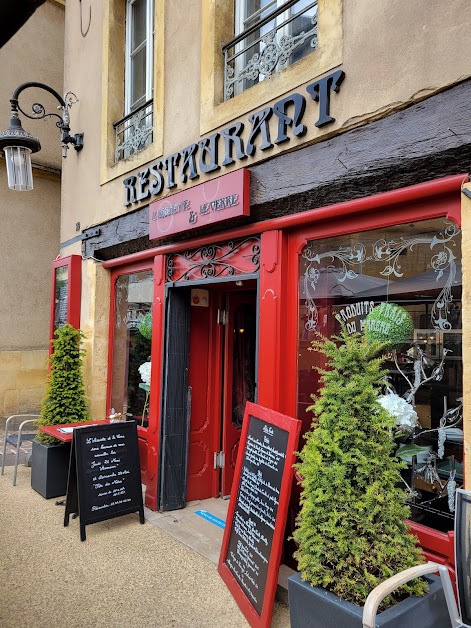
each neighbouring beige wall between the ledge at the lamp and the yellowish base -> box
[0,162,60,351]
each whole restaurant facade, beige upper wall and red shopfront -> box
[51,0,471,566]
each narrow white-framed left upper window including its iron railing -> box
[114,0,154,161]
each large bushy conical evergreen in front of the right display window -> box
[293,330,427,607]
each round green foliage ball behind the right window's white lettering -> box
[365,303,414,351]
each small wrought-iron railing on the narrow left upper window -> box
[113,100,154,163]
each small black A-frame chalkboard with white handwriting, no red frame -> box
[64,421,144,541]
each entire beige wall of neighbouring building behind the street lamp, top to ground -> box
[0,1,65,416]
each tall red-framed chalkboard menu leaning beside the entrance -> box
[218,402,301,627]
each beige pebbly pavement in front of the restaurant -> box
[0,465,290,628]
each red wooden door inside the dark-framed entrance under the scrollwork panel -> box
[187,286,256,501]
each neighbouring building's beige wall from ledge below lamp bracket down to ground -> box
[0,167,60,416]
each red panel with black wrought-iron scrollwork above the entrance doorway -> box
[166,237,260,281]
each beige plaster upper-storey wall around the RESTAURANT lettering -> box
[61,0,471,245]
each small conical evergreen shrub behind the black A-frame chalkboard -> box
[36,325,90,445]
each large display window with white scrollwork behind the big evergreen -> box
[297,218,463,532]
